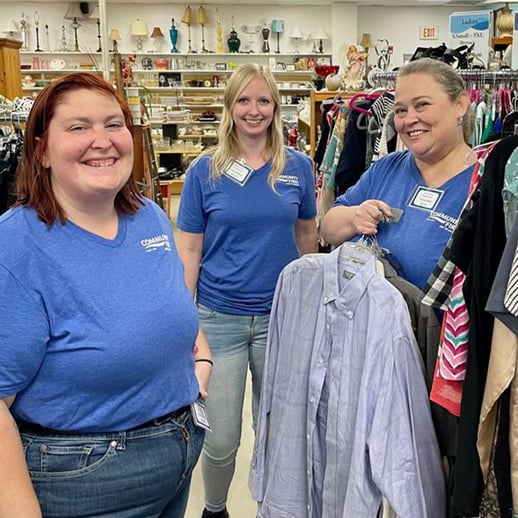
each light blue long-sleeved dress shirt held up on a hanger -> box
[249,244,446,518]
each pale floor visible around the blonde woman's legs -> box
[170,196,257,518]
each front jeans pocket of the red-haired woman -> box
[22,434,117,479]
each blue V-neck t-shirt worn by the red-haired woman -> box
[0,200,199,432]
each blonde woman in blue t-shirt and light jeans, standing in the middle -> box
[178,64,317,518]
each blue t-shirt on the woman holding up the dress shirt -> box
[335,151,474,289]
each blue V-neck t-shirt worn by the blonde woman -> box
[178,148,316,315]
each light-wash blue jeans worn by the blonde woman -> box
[198,304,270,511]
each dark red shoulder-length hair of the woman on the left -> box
[16,72,142,225]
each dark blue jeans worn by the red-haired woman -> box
[21,411,205,518]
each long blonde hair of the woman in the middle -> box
[201,64,286,191]
